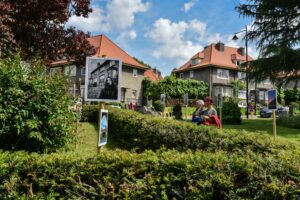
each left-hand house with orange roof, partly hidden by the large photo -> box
[49,35,148,105]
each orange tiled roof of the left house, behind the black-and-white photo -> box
[88,35,149,69]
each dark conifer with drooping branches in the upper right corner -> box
[236,0,300,81]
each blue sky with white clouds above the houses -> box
[67,0,257,75]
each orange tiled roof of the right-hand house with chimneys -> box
[174,43,253,72]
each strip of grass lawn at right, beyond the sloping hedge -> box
[223,118,300,142]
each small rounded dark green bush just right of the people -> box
[222,99,242,124]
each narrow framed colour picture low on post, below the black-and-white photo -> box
[98,109,108,147]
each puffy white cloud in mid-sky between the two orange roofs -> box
[147,18,206,65]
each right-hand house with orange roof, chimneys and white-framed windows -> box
[173,42,274,105]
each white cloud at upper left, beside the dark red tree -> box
[67,0,150,39]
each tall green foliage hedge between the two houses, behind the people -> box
[143,76,208,98]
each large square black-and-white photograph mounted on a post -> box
[85,57,122,102]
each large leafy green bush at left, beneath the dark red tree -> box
[0,56,76,152]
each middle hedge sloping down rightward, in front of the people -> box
[108,109,294,154]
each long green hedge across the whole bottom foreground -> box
[0,150,300,199]
